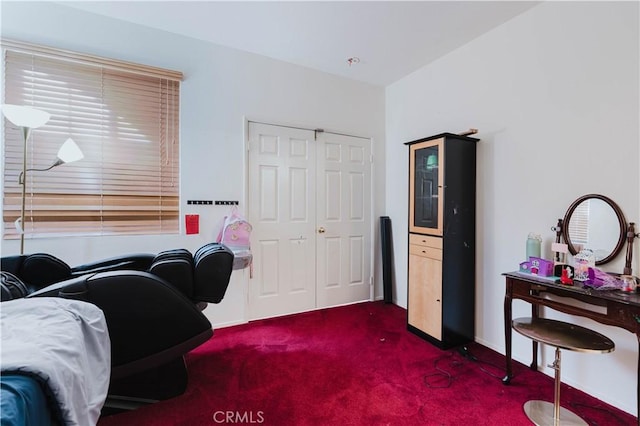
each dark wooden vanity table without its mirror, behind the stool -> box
[502,272,640,422]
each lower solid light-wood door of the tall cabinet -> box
[408,245,442,340]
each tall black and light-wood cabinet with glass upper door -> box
[407,133,478,349]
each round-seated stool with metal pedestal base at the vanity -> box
[512,318,615,426]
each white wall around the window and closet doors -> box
[1,2,384,327]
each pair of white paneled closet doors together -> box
[248,122,373,319]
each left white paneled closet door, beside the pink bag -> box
[248,122,316,319]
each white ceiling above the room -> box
[60,0,540,86]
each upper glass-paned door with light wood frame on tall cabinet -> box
[409,138,444,236]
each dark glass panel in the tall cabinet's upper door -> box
[413,145,440,233]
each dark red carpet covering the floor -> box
[99,302,637,426]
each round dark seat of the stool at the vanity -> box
[513,318,615,353]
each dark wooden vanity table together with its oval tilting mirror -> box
[502,194,640,425]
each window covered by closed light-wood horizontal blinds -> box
[2,40,182,238]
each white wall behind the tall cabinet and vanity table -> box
[386,2,640,414]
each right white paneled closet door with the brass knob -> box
[316,133,373,308]
